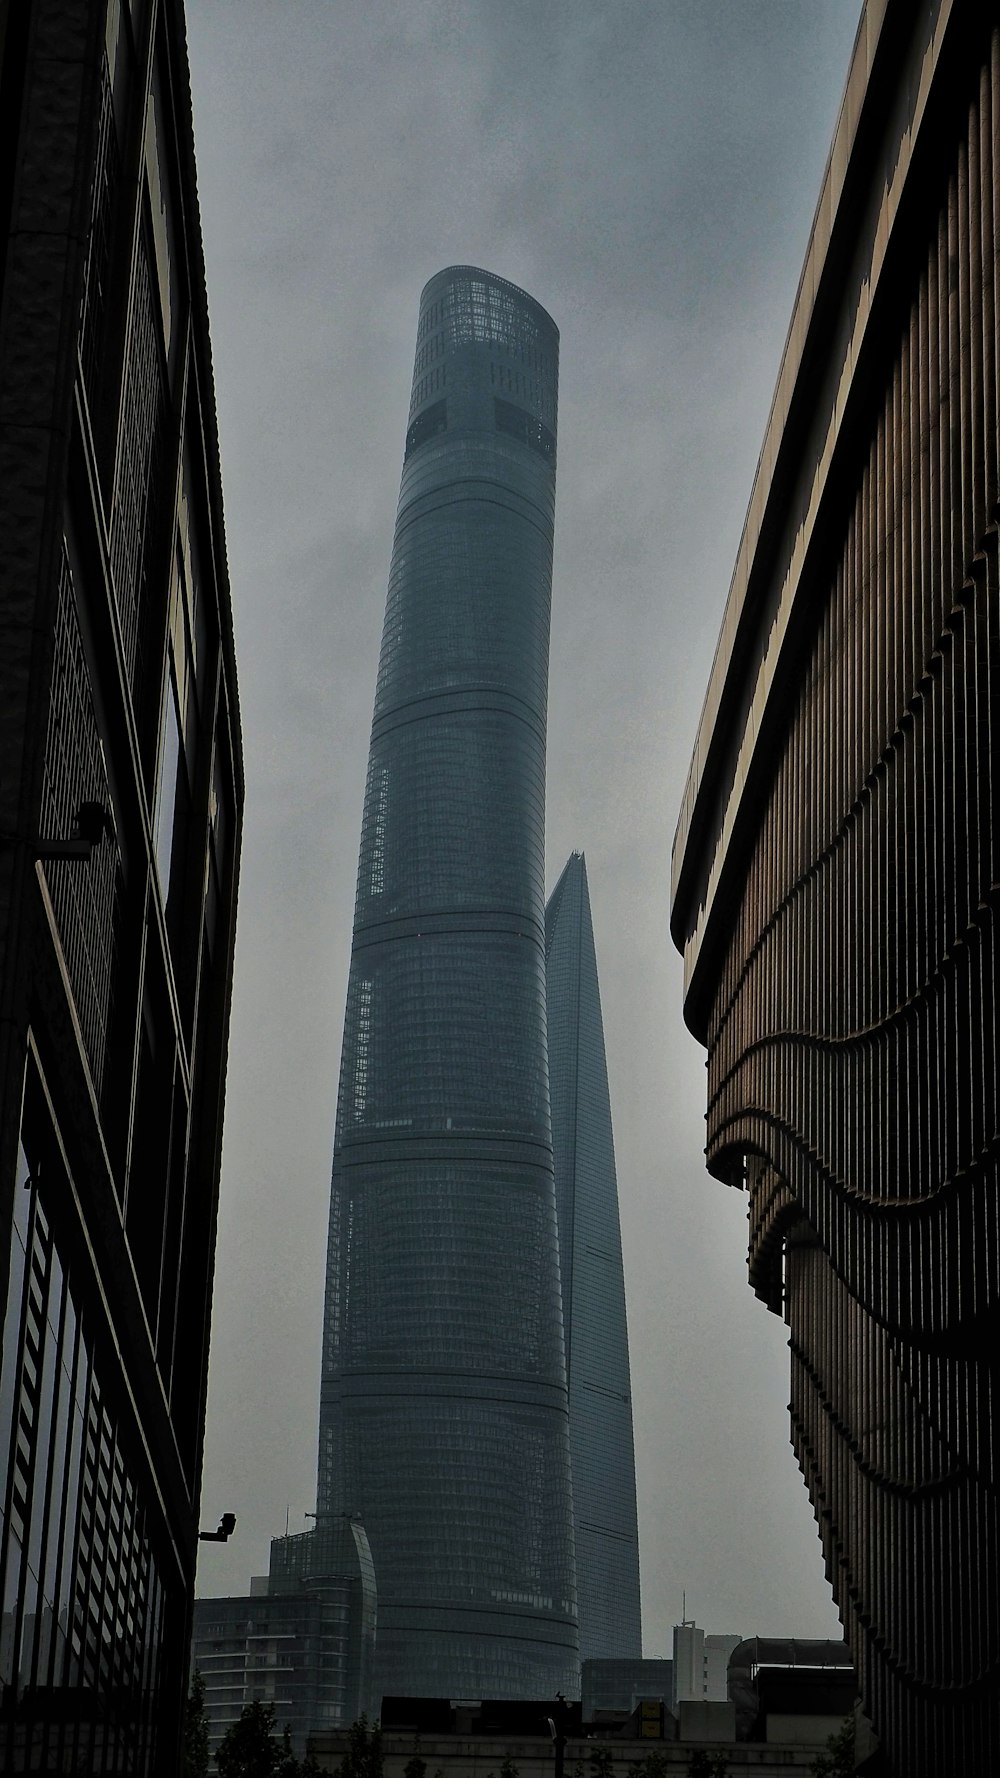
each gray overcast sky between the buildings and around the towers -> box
[189,0,859,1655]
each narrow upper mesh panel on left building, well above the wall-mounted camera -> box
[110,235,165,685]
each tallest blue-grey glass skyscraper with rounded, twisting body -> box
[319,267,578,1698]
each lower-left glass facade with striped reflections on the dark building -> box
[0,1145,164,1771]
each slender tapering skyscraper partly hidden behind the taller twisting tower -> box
[544,852,642,1659]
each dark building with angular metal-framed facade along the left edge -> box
[0,0,242,1774]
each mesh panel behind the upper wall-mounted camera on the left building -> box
[39,553,121,1092]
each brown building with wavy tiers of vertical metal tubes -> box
[674,0,1000,1778]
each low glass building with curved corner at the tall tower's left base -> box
[190,1518,377,1753]
